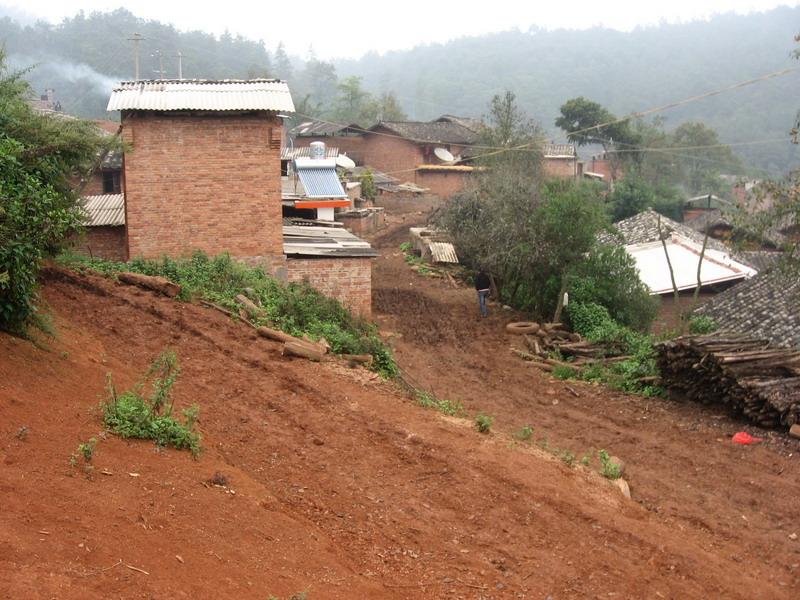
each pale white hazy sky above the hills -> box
[7,0,800,58]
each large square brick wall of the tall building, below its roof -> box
[122,112,283,264]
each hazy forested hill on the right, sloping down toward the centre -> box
[336,7,800,172]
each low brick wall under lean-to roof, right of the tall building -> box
[286,258,372,318]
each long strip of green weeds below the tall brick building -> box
[58,252,397,377]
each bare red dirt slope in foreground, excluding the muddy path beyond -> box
[0,271,800,600]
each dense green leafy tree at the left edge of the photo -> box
[0,52,115,334]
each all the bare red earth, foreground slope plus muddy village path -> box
[0,198,800,600]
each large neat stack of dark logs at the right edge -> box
[657,333,800,428]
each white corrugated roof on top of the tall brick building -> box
[107,79,294,112]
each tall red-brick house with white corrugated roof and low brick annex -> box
[104,79,376,316]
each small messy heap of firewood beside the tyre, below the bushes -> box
[506,322,628,372]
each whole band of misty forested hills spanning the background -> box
[0,7,800,174]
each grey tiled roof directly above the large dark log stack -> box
[695,266,800,346]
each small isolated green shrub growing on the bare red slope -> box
[100,350,201,456]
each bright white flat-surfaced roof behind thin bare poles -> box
[625,234,756,295]
